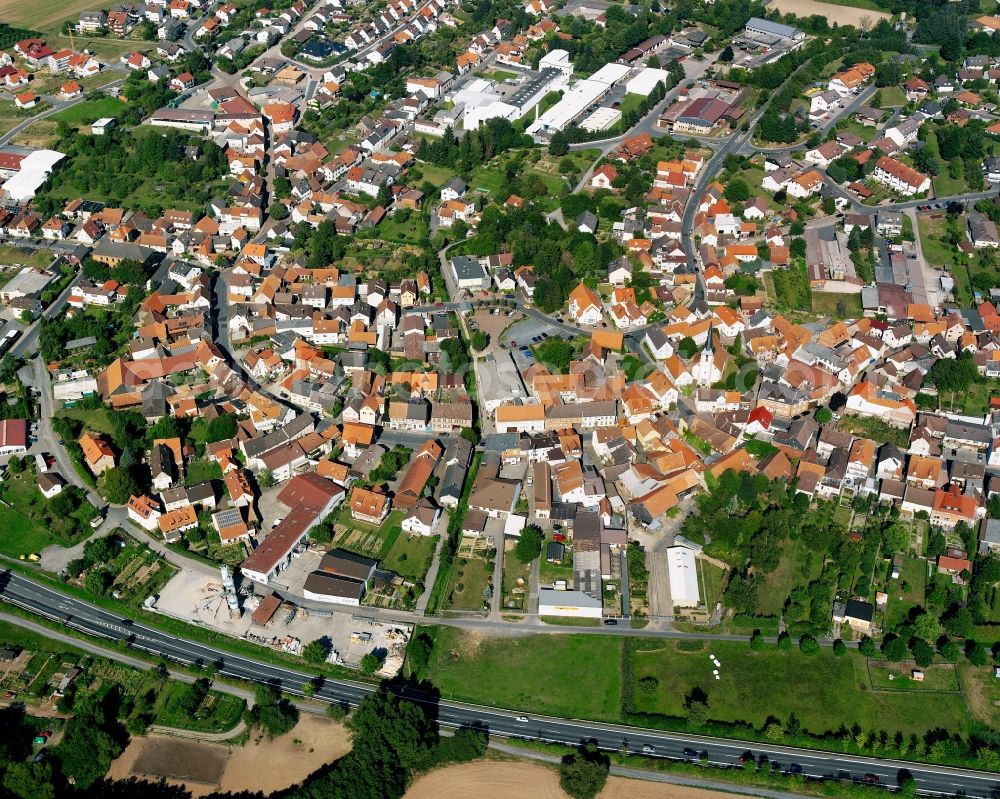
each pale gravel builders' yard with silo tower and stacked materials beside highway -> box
[156,564,410,667]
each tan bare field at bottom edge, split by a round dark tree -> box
[403,761,730,799]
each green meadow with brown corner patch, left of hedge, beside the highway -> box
[427,627,621,721]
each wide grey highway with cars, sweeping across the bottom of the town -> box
[0,572,1000,799]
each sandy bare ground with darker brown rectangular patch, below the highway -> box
[108,713,351,796]
